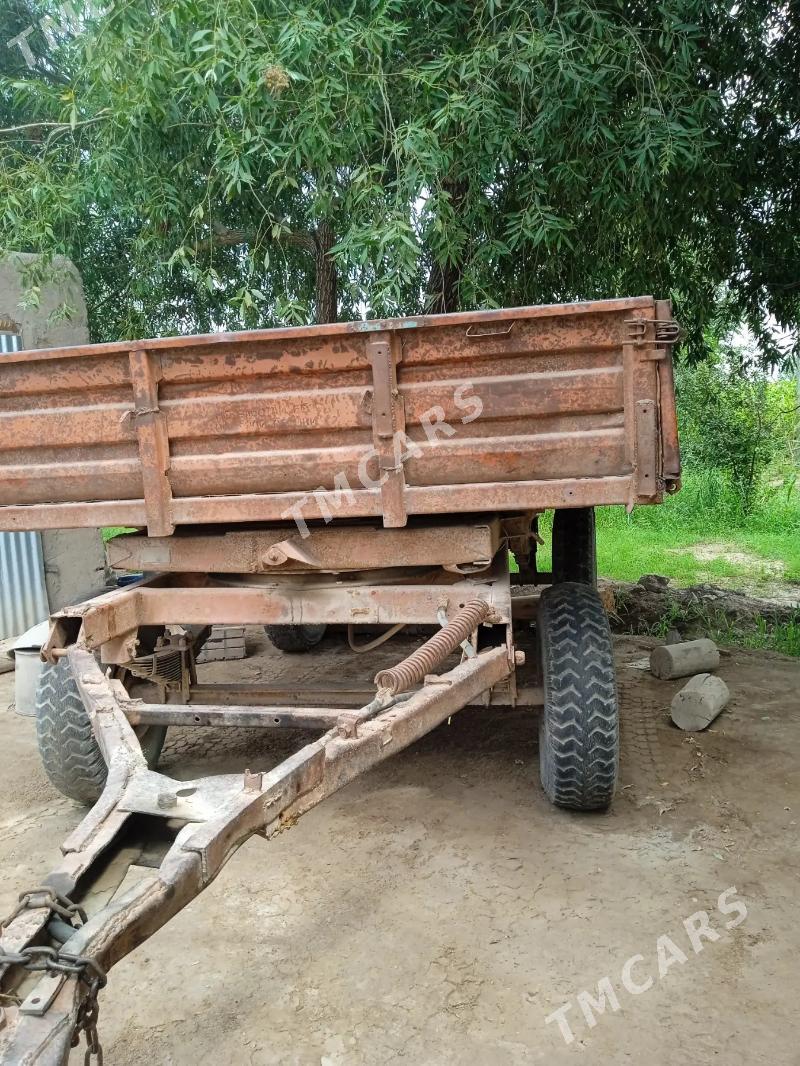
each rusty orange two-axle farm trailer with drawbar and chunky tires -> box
[0,297,679,1066]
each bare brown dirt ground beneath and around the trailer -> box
[0,637,800,1066]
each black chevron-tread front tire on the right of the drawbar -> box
[538,582,620,810]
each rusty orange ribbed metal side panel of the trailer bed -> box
[0,296,676,536]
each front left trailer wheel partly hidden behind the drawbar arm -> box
[36,658,166,804]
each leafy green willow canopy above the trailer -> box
[0,0,800,360]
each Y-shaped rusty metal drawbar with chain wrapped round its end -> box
[0,634,513,1066]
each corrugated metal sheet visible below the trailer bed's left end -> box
[0,533,50,640]
